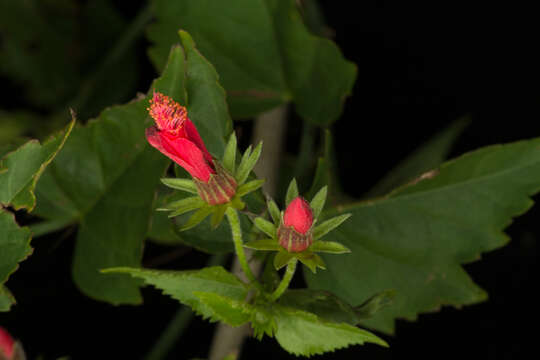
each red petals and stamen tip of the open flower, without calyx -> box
[146,92,216,183]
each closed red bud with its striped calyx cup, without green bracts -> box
[277,196,313,252]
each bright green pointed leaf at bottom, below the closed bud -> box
[275,307,388,356]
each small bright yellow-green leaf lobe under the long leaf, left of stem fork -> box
[193,291,250,326]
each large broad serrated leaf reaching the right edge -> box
[306,139,540,332]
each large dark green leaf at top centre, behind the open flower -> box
[147,0,356,125]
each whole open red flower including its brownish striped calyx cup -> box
[146,92,237,205]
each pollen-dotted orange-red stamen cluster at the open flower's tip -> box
[147,92,187,134]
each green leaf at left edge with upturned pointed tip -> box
[0,118,75,211]
